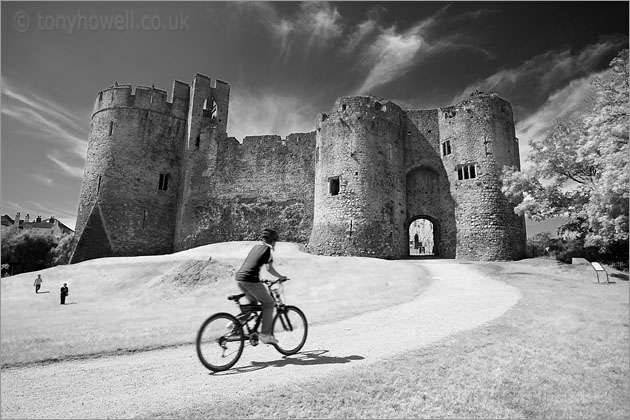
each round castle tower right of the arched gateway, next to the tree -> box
[438,94,526,260]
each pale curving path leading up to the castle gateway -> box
[0,260,520,418]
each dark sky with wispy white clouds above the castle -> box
[0,1,629,236]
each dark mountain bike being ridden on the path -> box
[196,279,308,372]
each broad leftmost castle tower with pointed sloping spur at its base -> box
[71,81,189,262]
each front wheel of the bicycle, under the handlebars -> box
[273,306,308,356]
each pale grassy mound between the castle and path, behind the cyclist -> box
[0,242,431,367]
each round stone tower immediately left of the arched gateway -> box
[308,96,406,258]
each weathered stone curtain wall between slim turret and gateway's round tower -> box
[177,132,315,249]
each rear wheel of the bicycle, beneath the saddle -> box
[197,312,245,372]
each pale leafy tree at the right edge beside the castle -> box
[503,49,630,251]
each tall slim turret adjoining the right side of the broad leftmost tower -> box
[174,74,230,250]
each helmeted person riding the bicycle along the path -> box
[235,229,286,344]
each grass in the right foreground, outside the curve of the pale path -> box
[156,259,630,419]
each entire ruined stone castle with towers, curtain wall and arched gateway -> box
[72,74,525,262]
